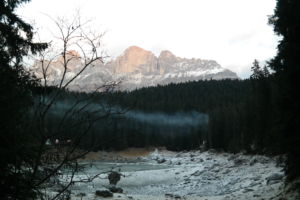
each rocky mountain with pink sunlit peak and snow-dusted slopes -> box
[32,46,238,91]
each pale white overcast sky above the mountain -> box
[18,0,279,78]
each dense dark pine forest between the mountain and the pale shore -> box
[41,66,283,154]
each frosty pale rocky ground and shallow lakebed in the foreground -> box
[55,150,296,200]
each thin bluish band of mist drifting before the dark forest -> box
[40,99,209,140]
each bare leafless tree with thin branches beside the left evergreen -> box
[27,13,122,199]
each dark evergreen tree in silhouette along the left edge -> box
[0,0,47,199]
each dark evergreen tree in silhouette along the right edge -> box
[270,0,300,179]
